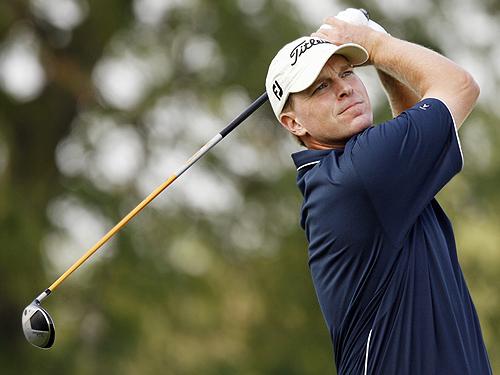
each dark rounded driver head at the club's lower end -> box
[22,301,56,349]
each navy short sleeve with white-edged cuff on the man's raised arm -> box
[351,98,463,244]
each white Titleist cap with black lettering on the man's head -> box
[266,36,368,120]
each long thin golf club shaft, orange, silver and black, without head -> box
[35,92,268,303]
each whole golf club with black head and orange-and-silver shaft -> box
[22,92,268,349]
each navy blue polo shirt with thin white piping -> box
[292,99,492,375]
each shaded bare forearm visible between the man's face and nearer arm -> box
[377,69,422,117]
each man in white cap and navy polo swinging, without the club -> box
[266,9,491,375]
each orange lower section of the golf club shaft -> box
[48,174,178,292]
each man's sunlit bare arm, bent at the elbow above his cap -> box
[313,17,479,128]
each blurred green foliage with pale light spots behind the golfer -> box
[0,0,500,374]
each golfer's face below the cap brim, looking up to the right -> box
[293,55,373,148]
